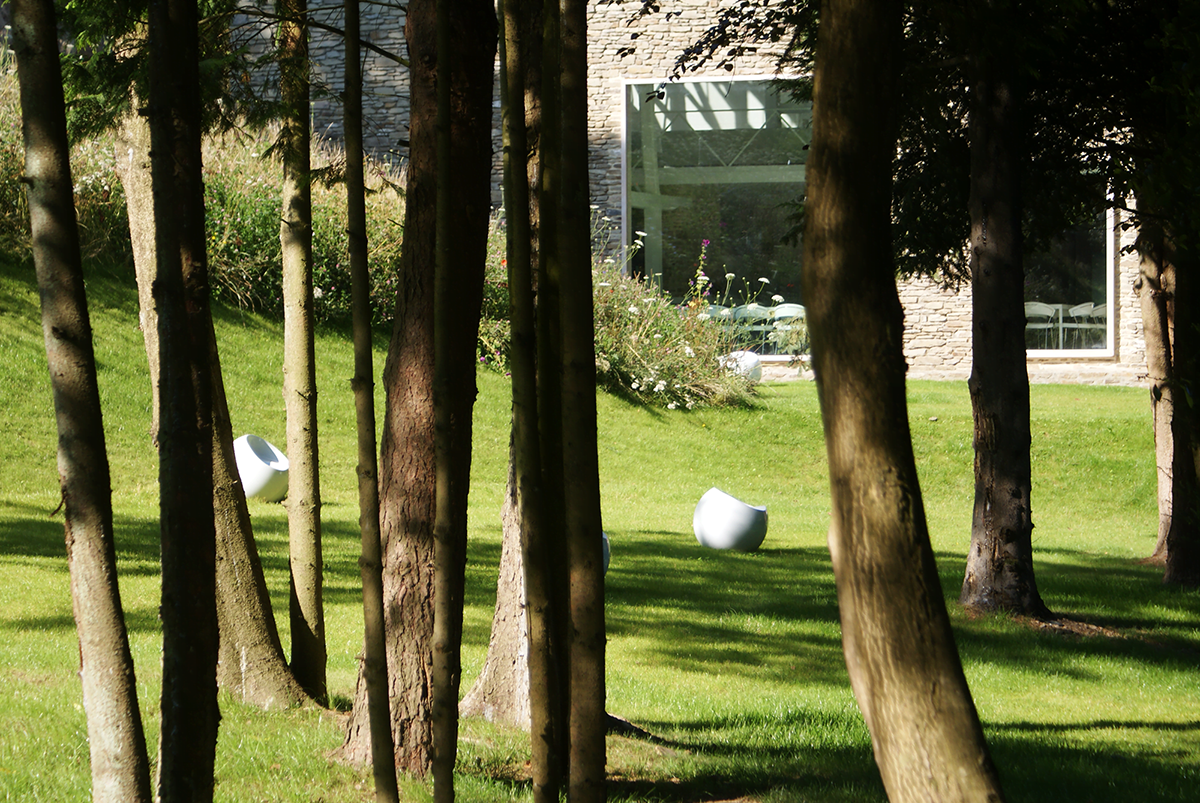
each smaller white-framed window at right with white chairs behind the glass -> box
[1025,211,1112,354]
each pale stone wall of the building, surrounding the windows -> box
[278,0,1145,384]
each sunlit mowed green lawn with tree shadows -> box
[0,252,1200,803]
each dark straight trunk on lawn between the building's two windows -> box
[959,2,1050,618]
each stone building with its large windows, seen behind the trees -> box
[297,0,1145,384]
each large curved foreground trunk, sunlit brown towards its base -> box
[804,0,1002,803]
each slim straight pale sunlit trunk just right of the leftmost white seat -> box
[276,0,326,701]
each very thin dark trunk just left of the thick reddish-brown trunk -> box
[343,0,400,803]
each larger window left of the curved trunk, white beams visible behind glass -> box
[625,80,812,304]
